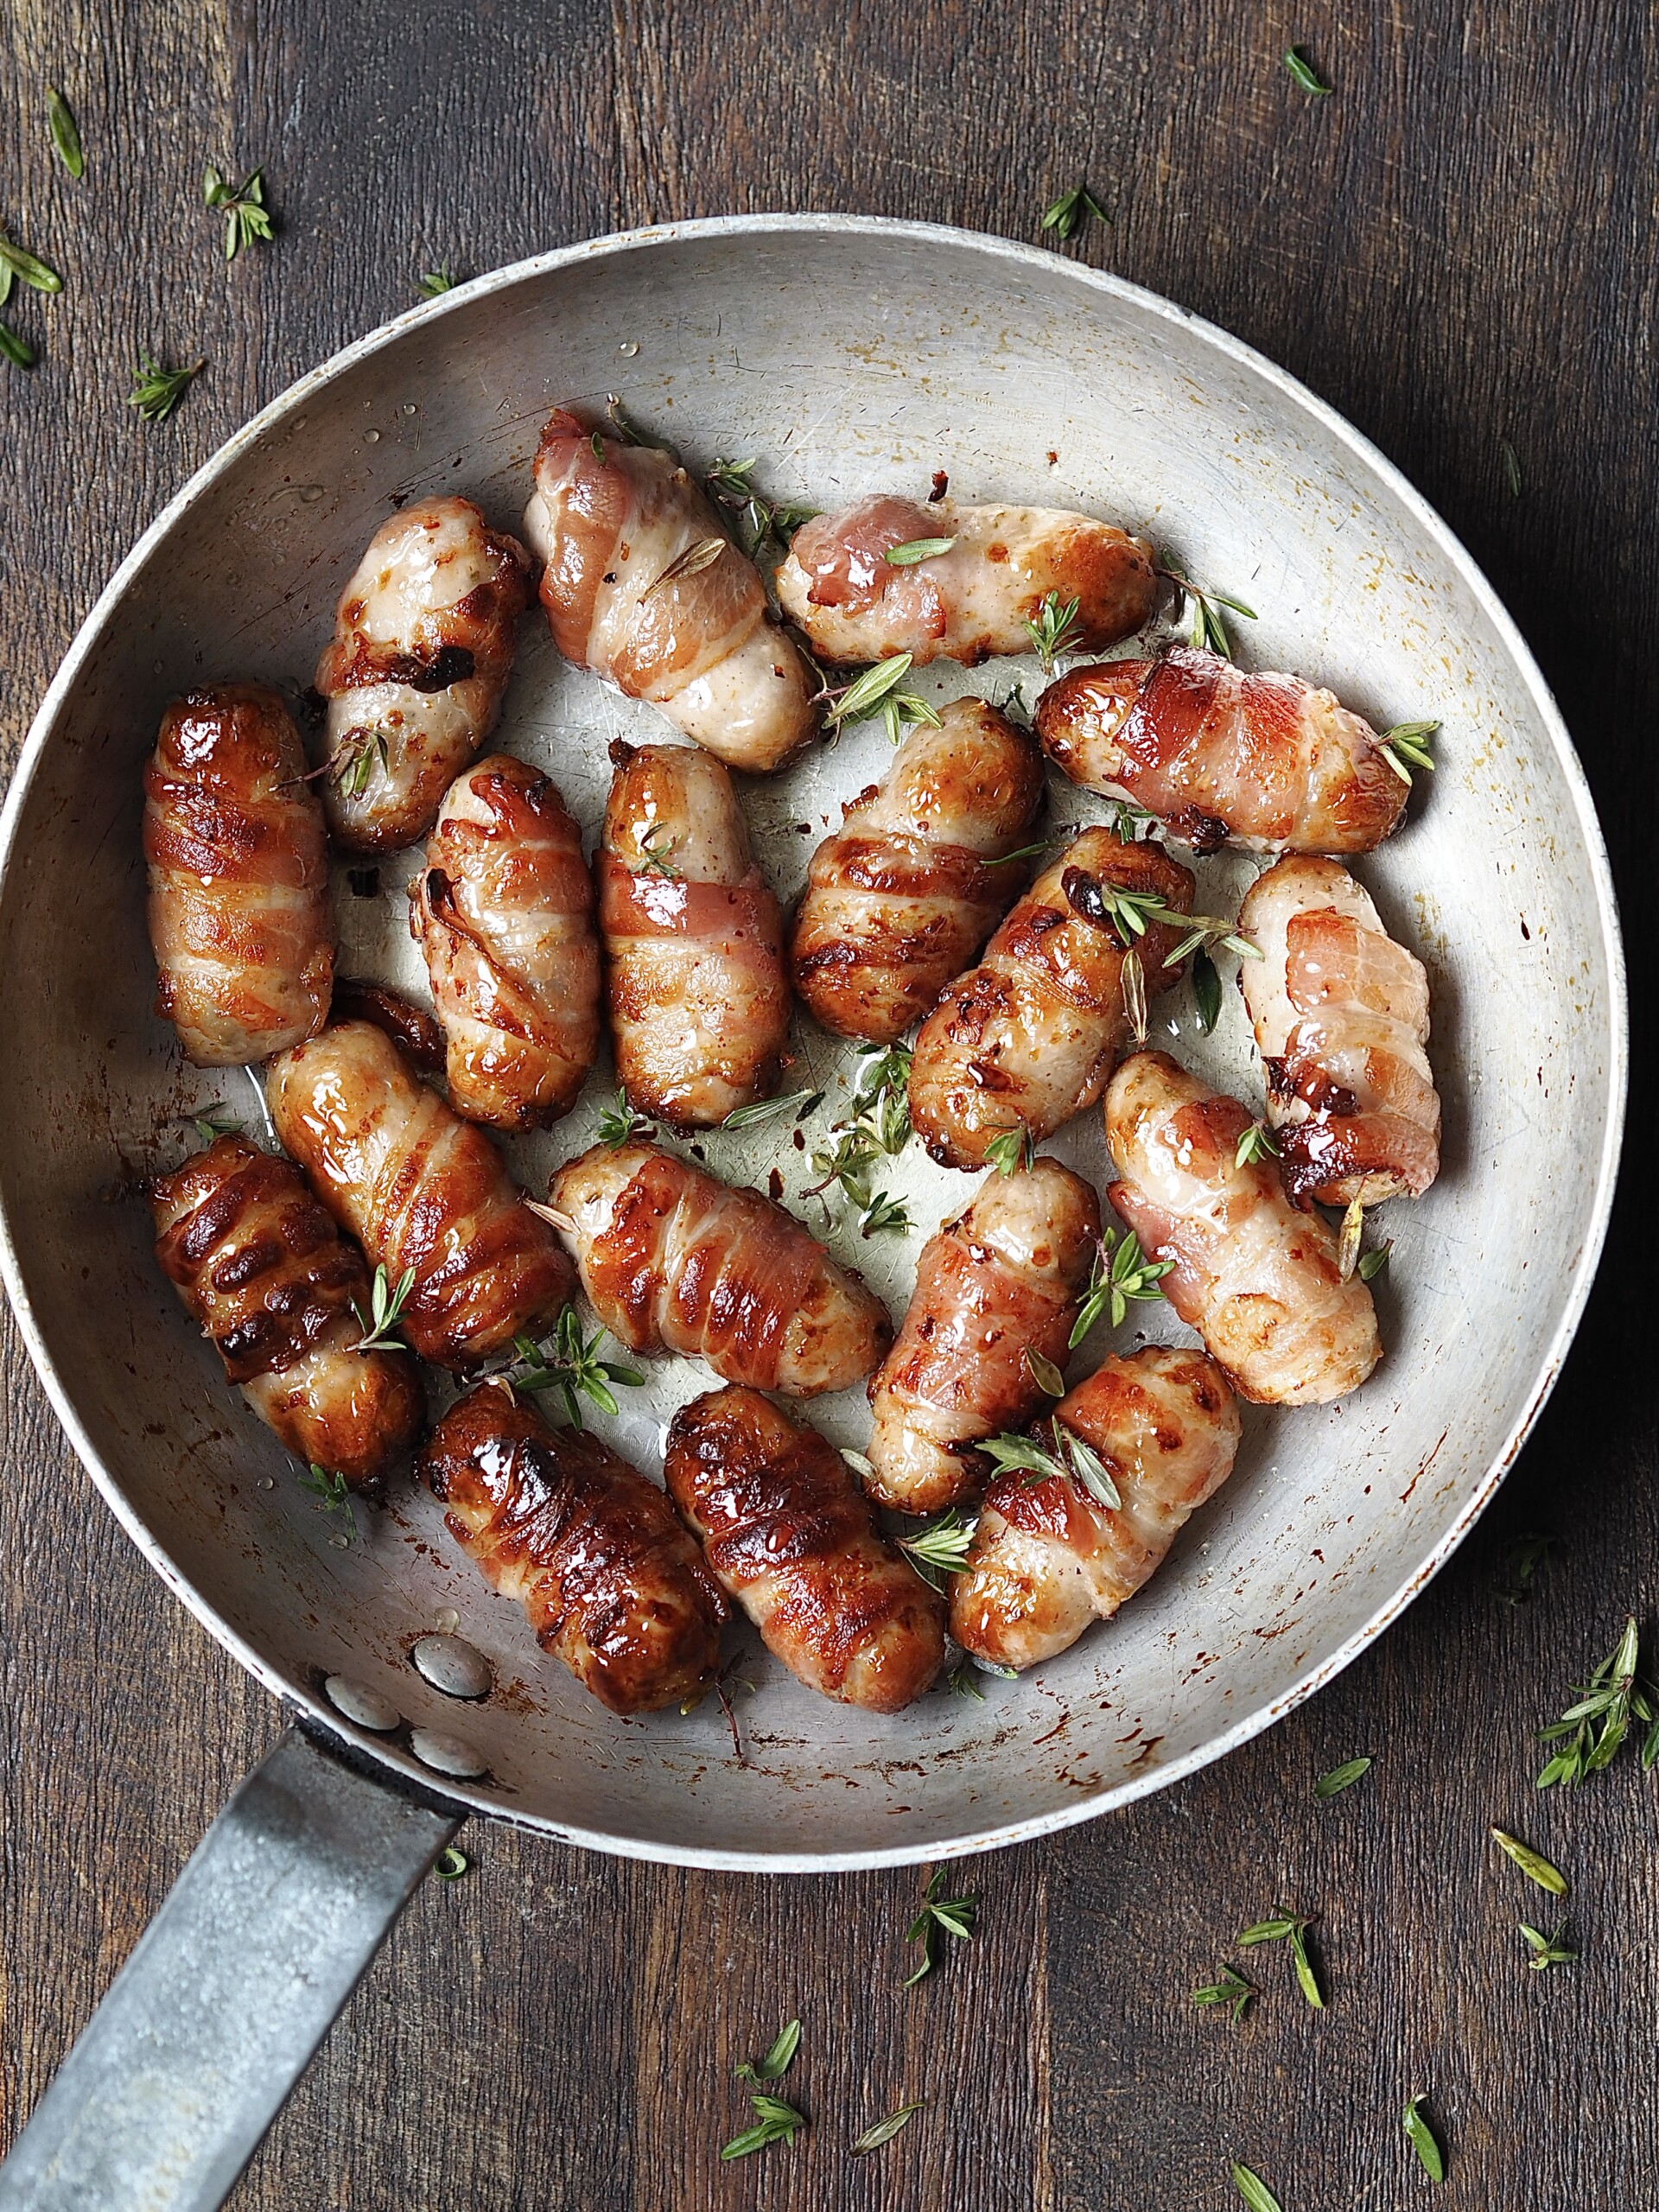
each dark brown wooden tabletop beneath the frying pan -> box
[0,0,1659,2212]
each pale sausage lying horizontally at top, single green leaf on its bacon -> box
[777,493,1157,666]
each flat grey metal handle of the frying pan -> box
[0,1730,465,2212]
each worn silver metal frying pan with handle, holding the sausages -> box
[0,217,1626,2212]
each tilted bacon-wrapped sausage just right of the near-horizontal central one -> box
[865,1159,1099,1513]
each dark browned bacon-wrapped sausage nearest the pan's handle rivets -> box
[418,1382,728,1712]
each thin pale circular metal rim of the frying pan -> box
[0,213,1630,1873]
